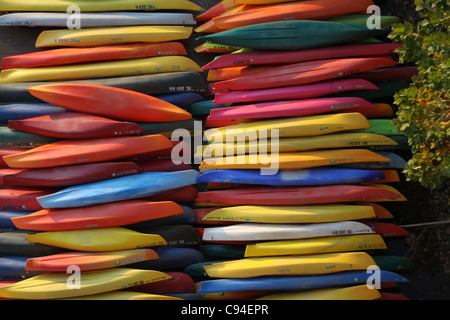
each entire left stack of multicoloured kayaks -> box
[0,0,214,300]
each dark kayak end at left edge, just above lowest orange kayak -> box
[0,231,66,258]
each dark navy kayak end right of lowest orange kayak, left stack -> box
[129,247,205,271]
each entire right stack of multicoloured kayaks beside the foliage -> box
[185,0,417,300]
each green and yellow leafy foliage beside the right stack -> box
[389,0,450,189]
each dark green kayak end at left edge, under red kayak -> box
[0,126,60,149]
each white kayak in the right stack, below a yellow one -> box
[202,221,375,241]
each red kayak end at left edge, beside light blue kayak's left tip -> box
[0,188,55,211]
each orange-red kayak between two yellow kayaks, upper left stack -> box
[2,42,187,69]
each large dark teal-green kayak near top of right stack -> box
[197,20,387,50]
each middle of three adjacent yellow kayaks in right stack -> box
[195,133,398,159]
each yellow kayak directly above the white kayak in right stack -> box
[202,204,375,223]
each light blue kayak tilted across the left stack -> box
[37,170,199,208]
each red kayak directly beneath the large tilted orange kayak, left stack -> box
[8,112,144,139]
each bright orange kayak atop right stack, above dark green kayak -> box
[213,0,373,30]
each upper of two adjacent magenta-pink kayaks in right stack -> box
[214,79,378,104]
